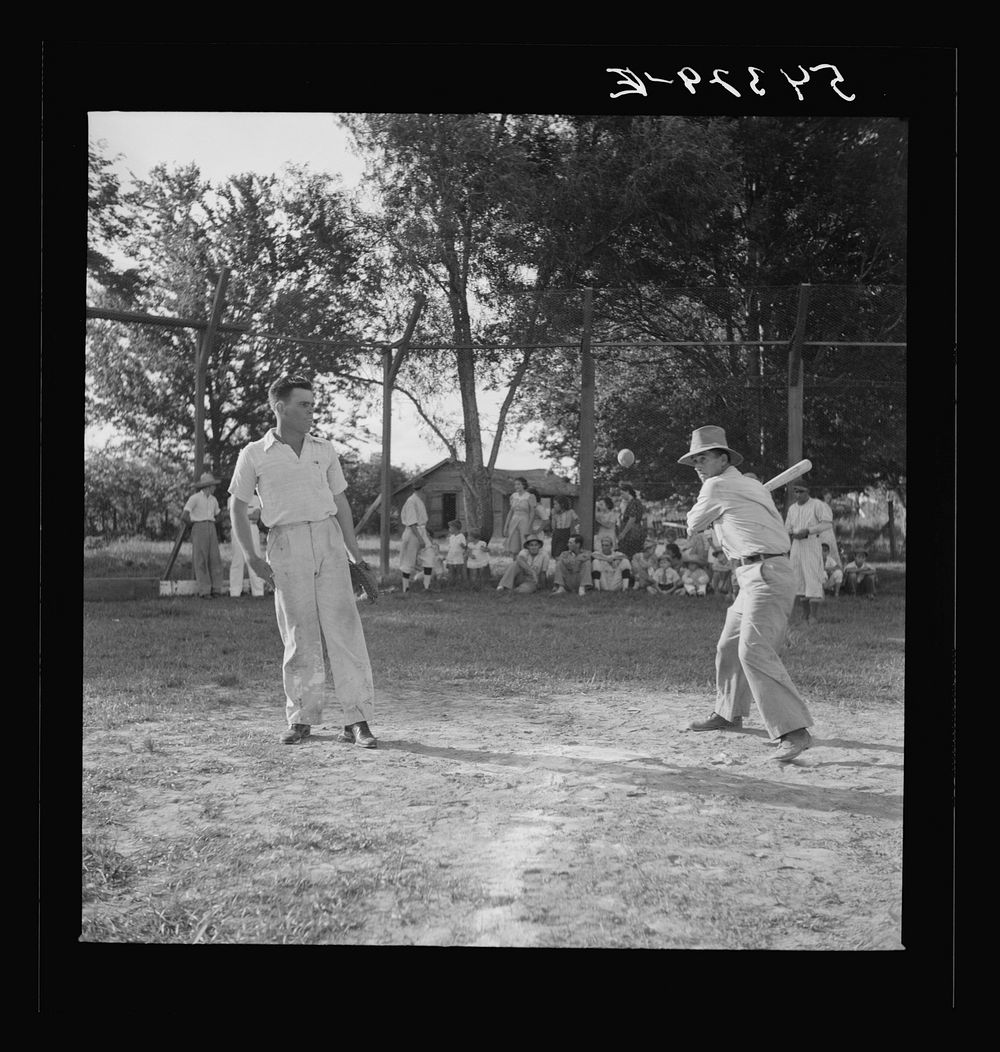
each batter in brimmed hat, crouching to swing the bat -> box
[677,426,813,763]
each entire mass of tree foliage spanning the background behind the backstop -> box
[87,114,906,523]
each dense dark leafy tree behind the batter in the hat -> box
[517,118,905,495]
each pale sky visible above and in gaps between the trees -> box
[86,112,549,469]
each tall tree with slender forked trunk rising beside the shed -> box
[345,114,740,537]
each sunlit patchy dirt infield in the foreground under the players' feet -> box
[82,681,903,950]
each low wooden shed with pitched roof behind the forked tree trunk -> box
[392,459,579,538]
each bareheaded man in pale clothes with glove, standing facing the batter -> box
[229,377,377,749]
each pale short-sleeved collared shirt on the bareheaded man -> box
[229,428,347,528]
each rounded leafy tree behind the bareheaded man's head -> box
[87,152,380,477]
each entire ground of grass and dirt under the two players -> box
[81,543,904,949]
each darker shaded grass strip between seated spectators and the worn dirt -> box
[84,567,903,721]
